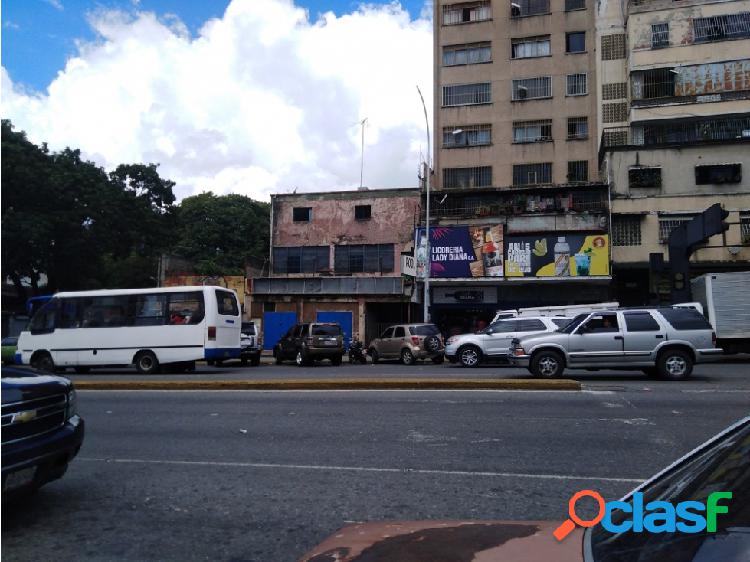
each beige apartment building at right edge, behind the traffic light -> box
[596,0,750,304]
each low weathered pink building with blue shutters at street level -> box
[251,188,419,349]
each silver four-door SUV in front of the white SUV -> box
[512,308,722,380]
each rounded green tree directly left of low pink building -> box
[174,191,270,275]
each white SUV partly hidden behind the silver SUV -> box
[445,316,571,367]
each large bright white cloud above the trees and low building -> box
[2,0,432,198]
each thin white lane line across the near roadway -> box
[76,457,645,484]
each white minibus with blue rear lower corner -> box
[16,286,242,374]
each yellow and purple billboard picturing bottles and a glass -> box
[505,232,609,277]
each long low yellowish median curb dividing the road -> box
[75,379,581,391]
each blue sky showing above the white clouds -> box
[2,0,424,91]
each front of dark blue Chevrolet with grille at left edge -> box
[2,367,84,501]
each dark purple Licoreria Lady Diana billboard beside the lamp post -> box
[414,225,503,278]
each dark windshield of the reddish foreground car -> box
[591,421,750,562]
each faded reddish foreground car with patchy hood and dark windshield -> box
[300,417,750,562]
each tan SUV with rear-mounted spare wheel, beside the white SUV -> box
[367,324,445,365]
